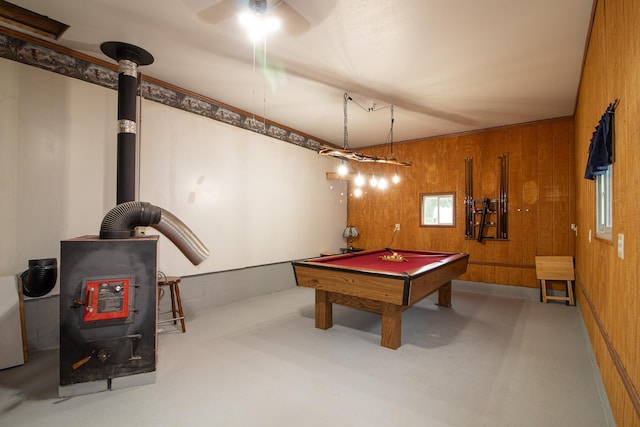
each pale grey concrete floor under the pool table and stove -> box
[0,288,612,427]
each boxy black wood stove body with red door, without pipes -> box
[59,236,158,396]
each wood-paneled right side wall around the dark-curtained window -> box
[575,0,640,412]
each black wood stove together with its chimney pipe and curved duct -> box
[58,42,209,397]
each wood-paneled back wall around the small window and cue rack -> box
[345,119,571,287]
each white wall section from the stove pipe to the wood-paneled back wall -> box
[140,101,347,275]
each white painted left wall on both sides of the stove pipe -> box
[0,59,347,294]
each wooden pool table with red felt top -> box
[292,249,469,350]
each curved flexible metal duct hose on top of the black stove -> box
[100,201,209,265]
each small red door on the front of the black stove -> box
[84,278,131,322]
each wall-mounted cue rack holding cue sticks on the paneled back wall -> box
[464,154,508,242]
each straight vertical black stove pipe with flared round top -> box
[100,41,153,204]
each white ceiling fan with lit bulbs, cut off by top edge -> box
[198,0,311,36]
